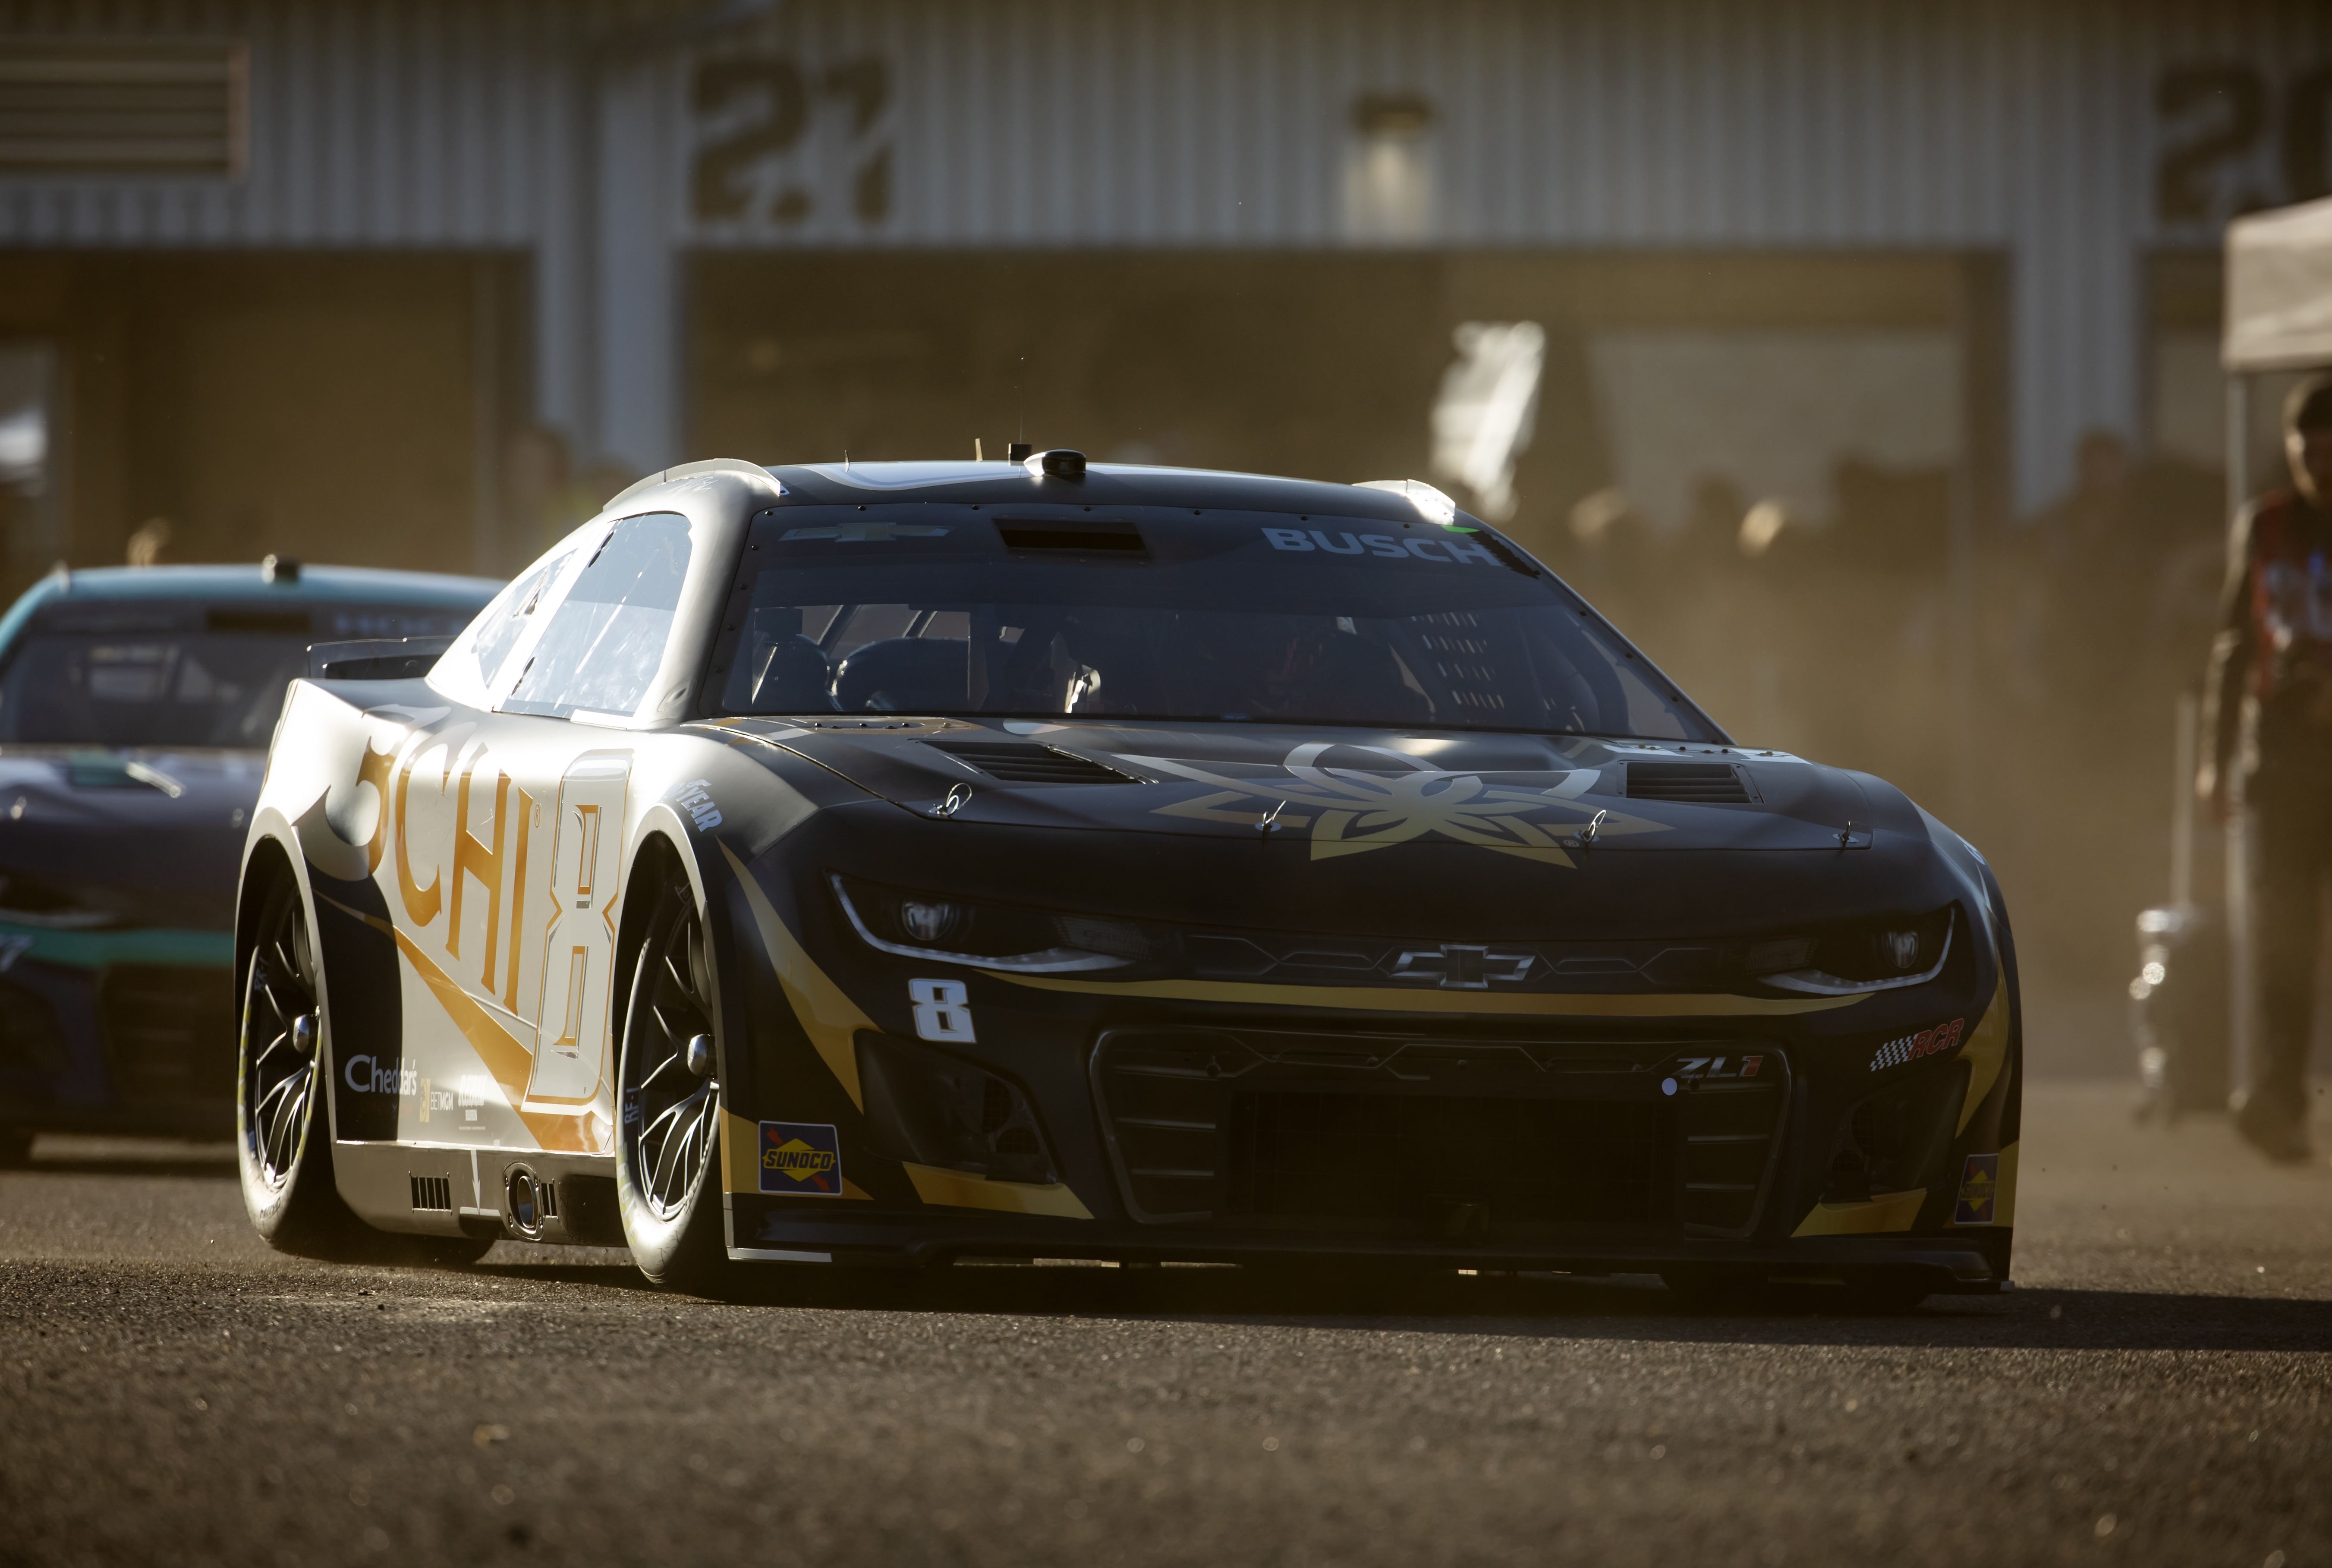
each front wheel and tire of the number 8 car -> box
[616,861,732,1295]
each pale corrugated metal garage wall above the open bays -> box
[0,0,2332,504]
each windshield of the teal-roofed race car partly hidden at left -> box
[0,605,469,749]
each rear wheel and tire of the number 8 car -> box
[236,880,492,1267]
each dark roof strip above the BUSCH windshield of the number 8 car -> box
[770,460,1446,523]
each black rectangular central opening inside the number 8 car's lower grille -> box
[1231,1094,1663,1225]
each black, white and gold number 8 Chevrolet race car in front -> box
[236,450,2022,1300]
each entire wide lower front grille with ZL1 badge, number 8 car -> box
[1094,1029,1789,1239]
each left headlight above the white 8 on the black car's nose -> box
[833,877,1152,975]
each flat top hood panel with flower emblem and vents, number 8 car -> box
[704,719,1893,866]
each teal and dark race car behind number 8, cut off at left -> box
[0,557,501,1162]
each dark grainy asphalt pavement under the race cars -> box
[0,1085,2332,1568]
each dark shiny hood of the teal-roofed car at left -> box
[0,744,266,929]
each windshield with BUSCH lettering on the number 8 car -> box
[707,504,1716,740]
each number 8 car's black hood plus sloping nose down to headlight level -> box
[709,716,1977,961]
